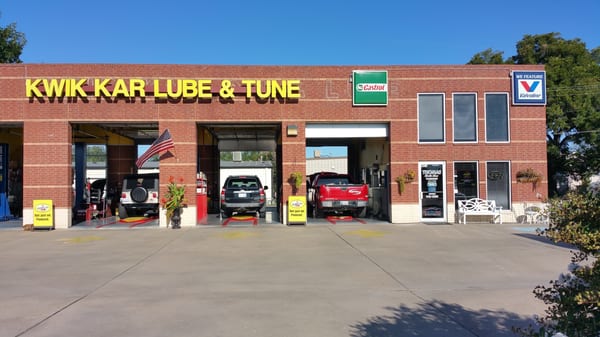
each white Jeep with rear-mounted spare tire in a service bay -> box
[119,173,159,219]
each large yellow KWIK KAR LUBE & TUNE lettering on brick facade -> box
[25,78,300,100]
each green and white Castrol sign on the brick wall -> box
[352,70,388,106]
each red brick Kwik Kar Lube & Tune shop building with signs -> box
[0,64,547,228]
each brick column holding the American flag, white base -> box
[158,119,198,227]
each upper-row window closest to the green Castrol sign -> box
[418,94,444,142]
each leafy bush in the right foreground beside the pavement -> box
[515,192,600,337]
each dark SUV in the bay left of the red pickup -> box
[221,176,268,217]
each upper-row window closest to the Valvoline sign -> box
[485,93,509,142]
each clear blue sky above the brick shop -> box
[0,0,600,65]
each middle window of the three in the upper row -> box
[452,94,477,142]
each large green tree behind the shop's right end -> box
[469,33,600,195]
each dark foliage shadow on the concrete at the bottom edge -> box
[351,301,535,337]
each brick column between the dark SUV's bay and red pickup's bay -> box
[279,121,306,224]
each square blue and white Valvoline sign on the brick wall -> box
[512,71,546,105]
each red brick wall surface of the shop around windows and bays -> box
[0,64,547,220]
